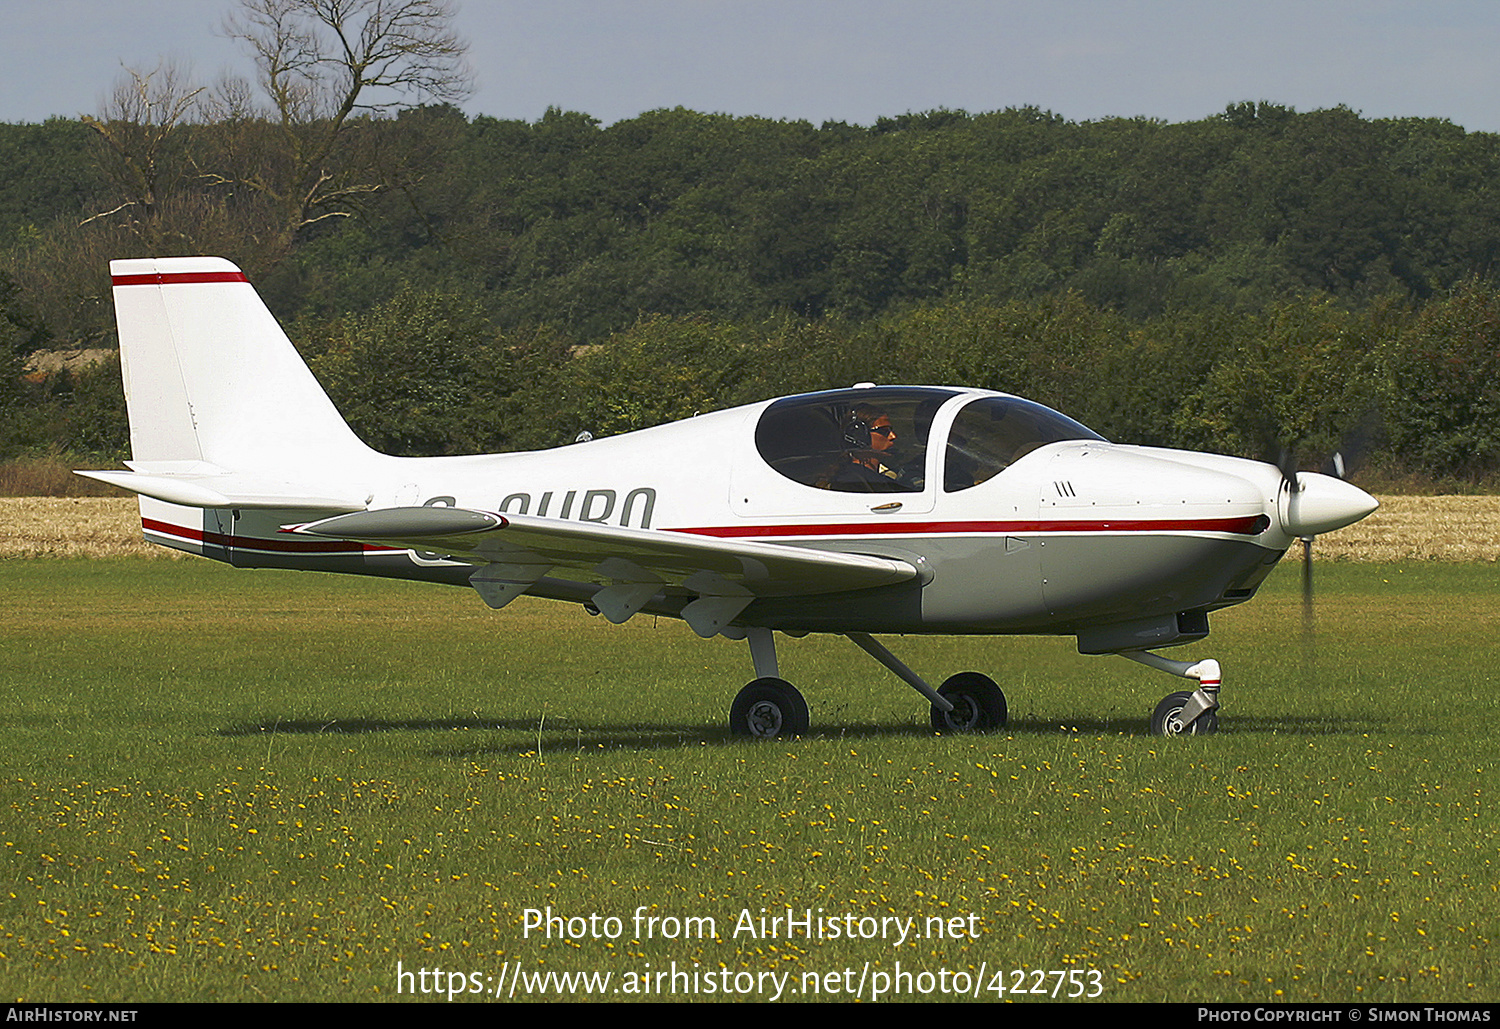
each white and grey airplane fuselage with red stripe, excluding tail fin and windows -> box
[143,390,1362,645]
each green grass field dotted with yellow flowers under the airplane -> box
[0,558,1500,1002]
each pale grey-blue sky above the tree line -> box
[0,0,1500,132]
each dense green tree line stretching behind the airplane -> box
[0,94,1500,482]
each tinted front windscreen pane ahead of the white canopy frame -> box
[942,396,1104,494]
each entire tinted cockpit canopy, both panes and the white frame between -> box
[755,387,1104,494]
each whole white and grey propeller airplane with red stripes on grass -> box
[80,258,1376,738]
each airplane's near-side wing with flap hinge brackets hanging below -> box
[285,507,918,636]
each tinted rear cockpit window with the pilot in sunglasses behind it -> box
[755,389,954,494]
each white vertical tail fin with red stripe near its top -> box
[110,258,378,479]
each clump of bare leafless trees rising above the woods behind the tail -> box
[73,0,471,272]
